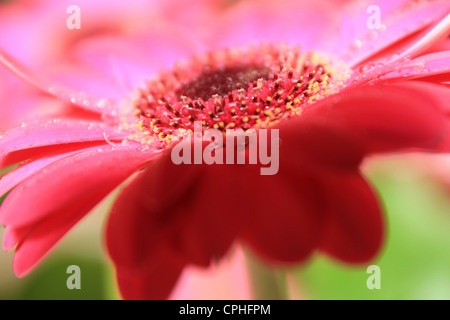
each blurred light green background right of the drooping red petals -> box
[296,156,450,299]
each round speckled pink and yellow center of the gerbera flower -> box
[127,45,349,147]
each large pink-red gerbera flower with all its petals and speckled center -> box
[0,0,450,298]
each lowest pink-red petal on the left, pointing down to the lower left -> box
[0,148,160,276]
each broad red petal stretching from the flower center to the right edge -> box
[300,82,450,153]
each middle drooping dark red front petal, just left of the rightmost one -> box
[236,158,324,263]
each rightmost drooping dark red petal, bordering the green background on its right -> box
[321,172,384,263]
